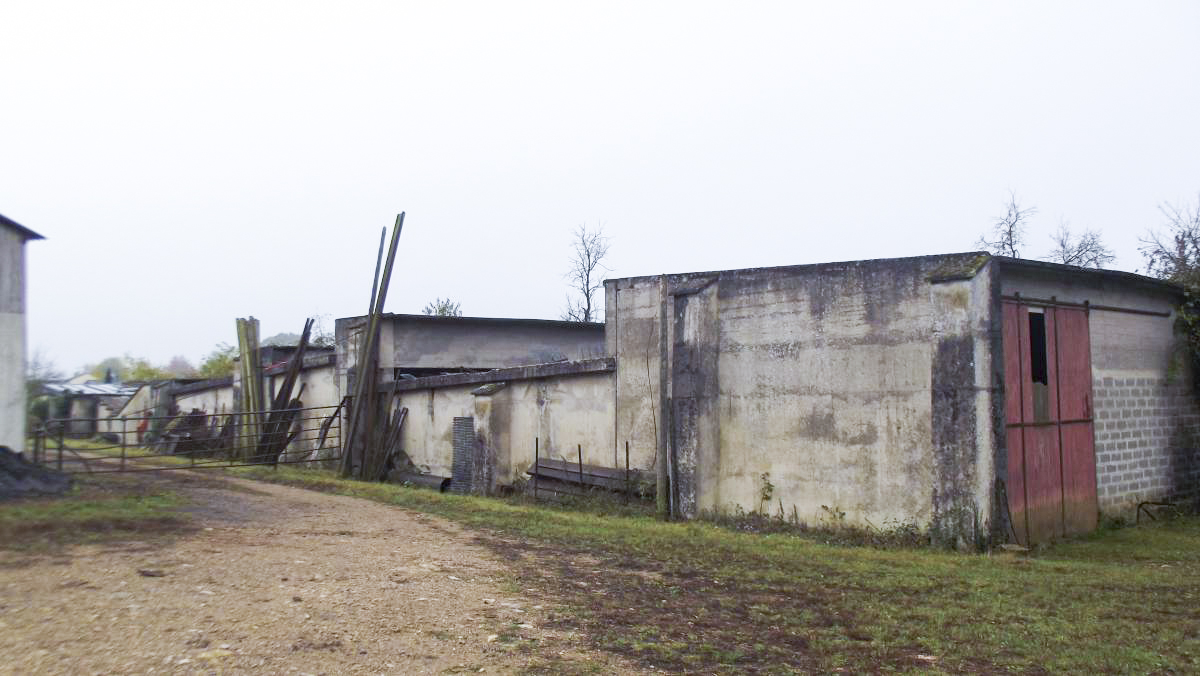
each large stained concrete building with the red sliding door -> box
[605,253,1200,543]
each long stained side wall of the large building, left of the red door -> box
[606,256,994,536]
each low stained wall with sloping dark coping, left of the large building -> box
[384,372,624,489]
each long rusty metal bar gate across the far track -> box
[32,406,342,473]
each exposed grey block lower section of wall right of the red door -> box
[1092,376,1200,518]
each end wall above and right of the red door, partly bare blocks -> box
[1002,268,1200,518]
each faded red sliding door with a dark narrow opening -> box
[1003,300,1097,545]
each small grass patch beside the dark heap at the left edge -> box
[0,474,185,550]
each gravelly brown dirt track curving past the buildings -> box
[0,472,631,674]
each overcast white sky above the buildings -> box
[0,0,1200,370]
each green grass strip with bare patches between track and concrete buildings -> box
[236,468,1200,674]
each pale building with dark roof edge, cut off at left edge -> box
[0,215,42,451]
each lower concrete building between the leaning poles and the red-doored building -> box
[335,315,604,491]
